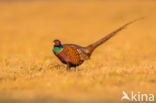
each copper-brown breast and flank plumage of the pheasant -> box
[56,45,83,65]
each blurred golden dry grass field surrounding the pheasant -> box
[0,0,156,103]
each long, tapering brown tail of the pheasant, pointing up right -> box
[86,17,145,56]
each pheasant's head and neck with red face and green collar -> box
[53,40,63,54]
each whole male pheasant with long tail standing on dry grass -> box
[52,18,143,70]
